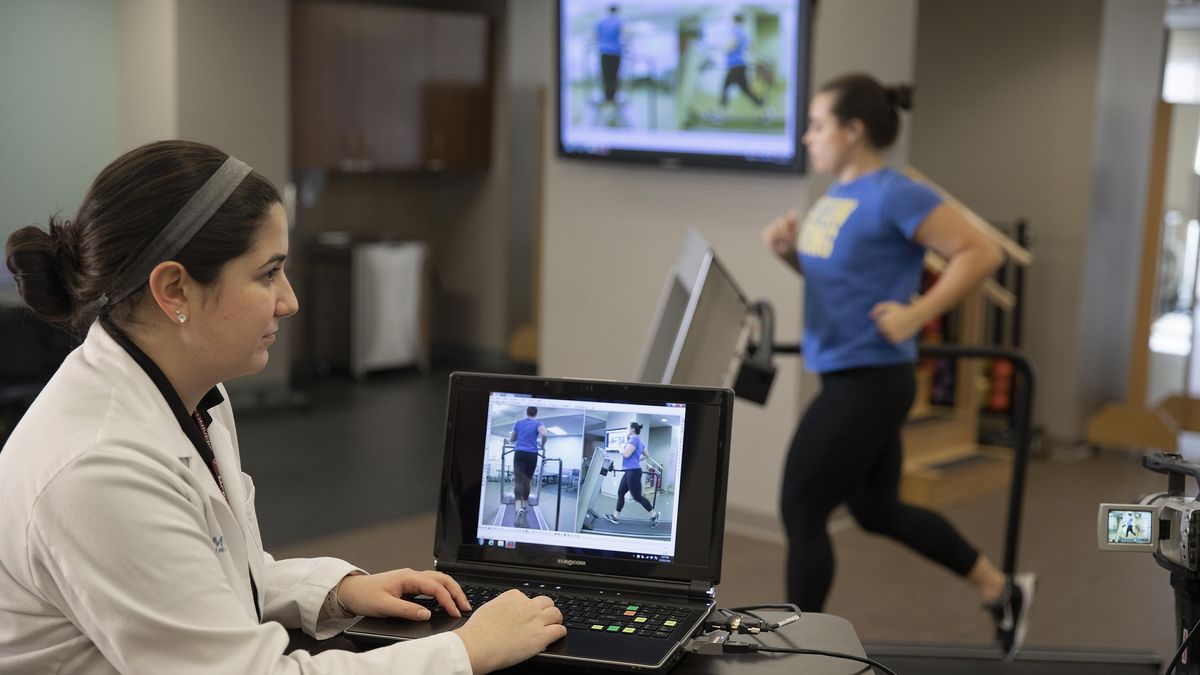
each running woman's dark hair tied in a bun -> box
[818,73,913,150]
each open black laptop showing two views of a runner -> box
[347,372,733,671]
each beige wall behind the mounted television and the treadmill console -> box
[540,0,916,521]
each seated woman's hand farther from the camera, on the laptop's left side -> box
[337,568,470,621]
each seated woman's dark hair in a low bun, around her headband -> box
[5,141,281,335]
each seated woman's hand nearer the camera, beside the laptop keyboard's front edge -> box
[455,589,566,675]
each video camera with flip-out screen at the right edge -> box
[1096,453,1200,675]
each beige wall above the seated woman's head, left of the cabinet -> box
[118,0,290,189]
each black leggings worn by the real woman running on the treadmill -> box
[780,364,979,611]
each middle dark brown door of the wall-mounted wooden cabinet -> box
[359,5,430,169]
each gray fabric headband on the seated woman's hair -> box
[98,156,253,307]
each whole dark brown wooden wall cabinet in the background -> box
[292,1,492,171]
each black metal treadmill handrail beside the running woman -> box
[772,345,1036,574]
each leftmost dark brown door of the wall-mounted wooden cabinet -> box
[292,2,360,168]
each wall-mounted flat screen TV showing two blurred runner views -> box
[558,0,811,172]
